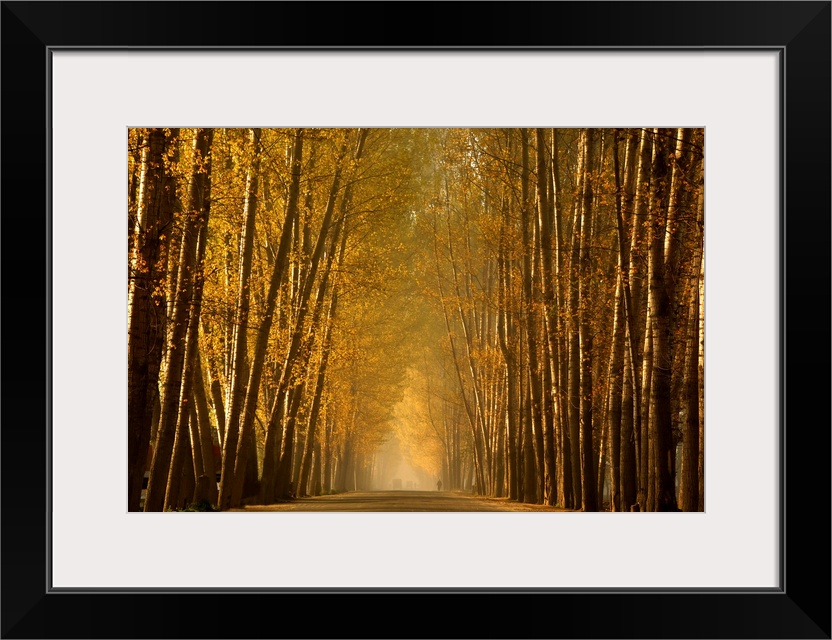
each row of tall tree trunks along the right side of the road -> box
[422,129,703,511]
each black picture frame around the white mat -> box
[0,1,832,638]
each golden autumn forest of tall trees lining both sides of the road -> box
[127,128,705,512]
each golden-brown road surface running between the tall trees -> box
[229,491,572,513]
